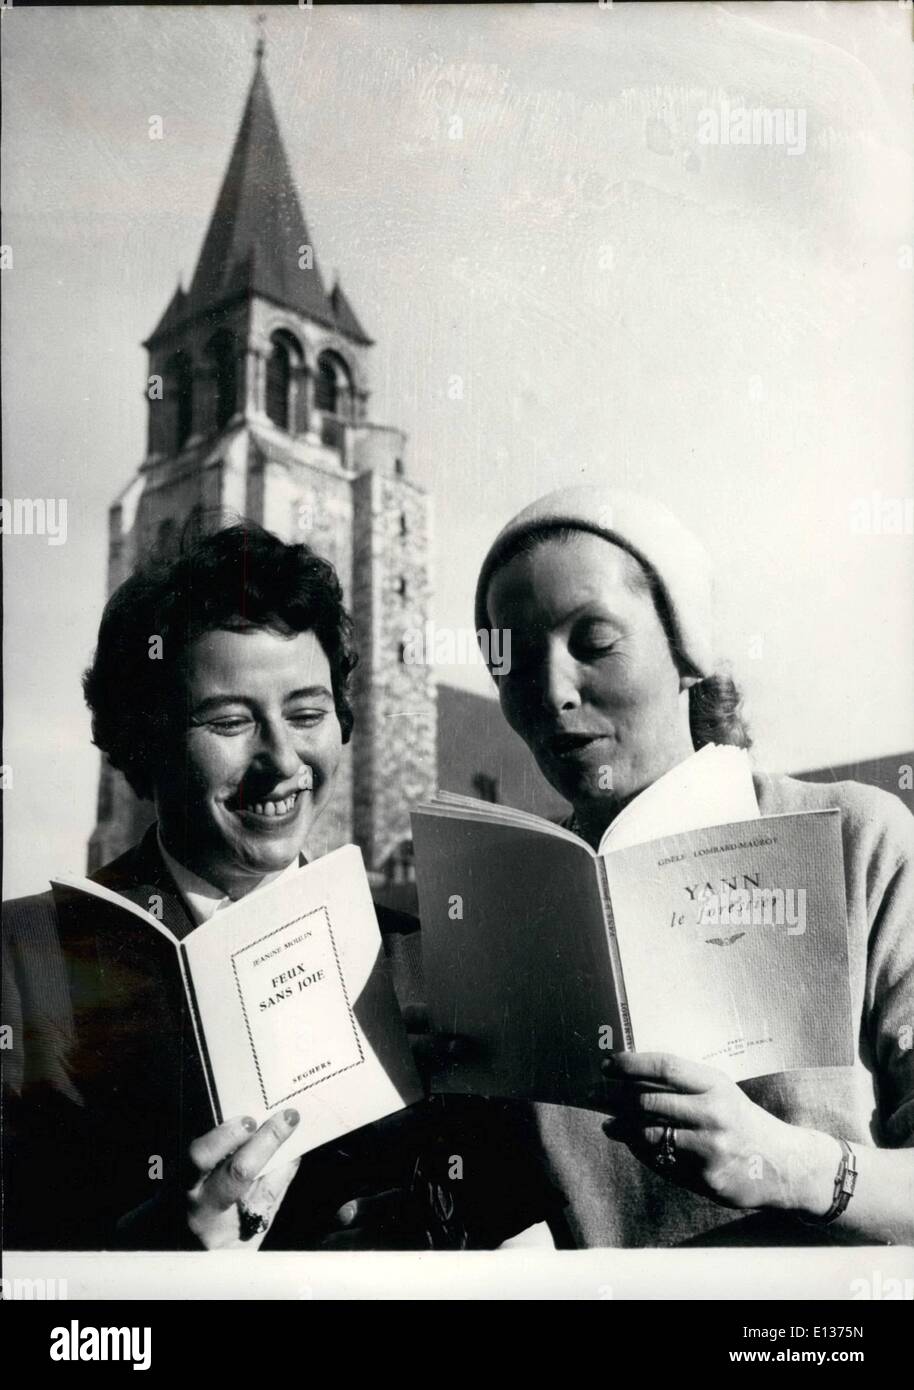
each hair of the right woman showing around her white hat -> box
[483,521,751,749]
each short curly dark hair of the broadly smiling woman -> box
[82,521,358,798]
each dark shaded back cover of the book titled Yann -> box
[413,810,621,1105]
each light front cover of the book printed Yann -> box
[604,810,854,1081]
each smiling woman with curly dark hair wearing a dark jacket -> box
[3,523,547,1250]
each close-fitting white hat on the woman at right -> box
[476,487,713,676]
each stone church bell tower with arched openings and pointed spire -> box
[89,48,436,880]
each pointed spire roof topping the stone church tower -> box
[147,54,371,345]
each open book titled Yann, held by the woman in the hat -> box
[413,746,854,1109]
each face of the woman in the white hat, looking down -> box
[488,531,693,838]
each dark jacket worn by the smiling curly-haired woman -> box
[1,827,551,1250]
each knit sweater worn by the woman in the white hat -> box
[522,774,914,1247]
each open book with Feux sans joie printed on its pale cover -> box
[53,845,422,1172]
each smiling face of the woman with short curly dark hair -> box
[154,628,342,898]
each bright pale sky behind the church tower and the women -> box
[1,3,914,895]
